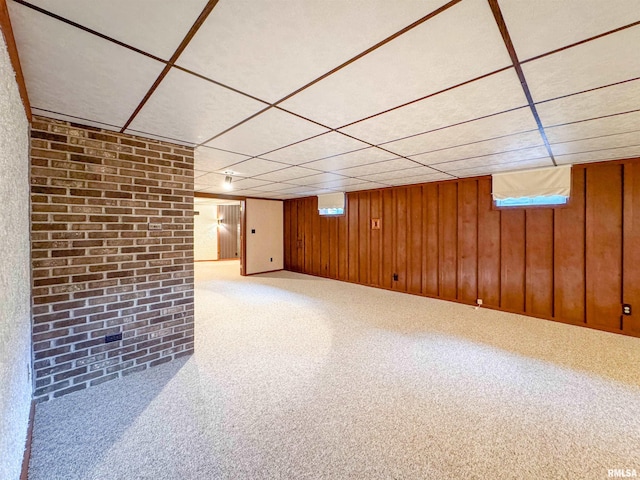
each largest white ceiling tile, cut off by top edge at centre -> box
[178,0,445,102]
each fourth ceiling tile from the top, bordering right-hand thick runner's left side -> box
[411,130,544,165]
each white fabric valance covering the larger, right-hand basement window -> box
[491,165,571,200]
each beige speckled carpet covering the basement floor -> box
[30,262,640,480]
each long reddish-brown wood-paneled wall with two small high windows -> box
[284,159,640,336]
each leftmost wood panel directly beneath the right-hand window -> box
[500,209,525,312]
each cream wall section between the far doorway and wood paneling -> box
[245,198,284,275]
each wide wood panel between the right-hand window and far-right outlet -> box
[586,164,622,330]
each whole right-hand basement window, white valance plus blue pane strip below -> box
[491,165,571,207]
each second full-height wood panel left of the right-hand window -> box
[458,180,478,304]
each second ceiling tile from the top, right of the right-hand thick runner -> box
[522,26,640,102]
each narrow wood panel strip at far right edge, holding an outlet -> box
[622,163,640,336]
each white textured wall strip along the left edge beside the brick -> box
[0,33,32,480]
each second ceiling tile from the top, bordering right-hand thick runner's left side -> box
[341,68,535,144]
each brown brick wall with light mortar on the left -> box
[31,117,194,401]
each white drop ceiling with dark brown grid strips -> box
[8,0,640,199]
